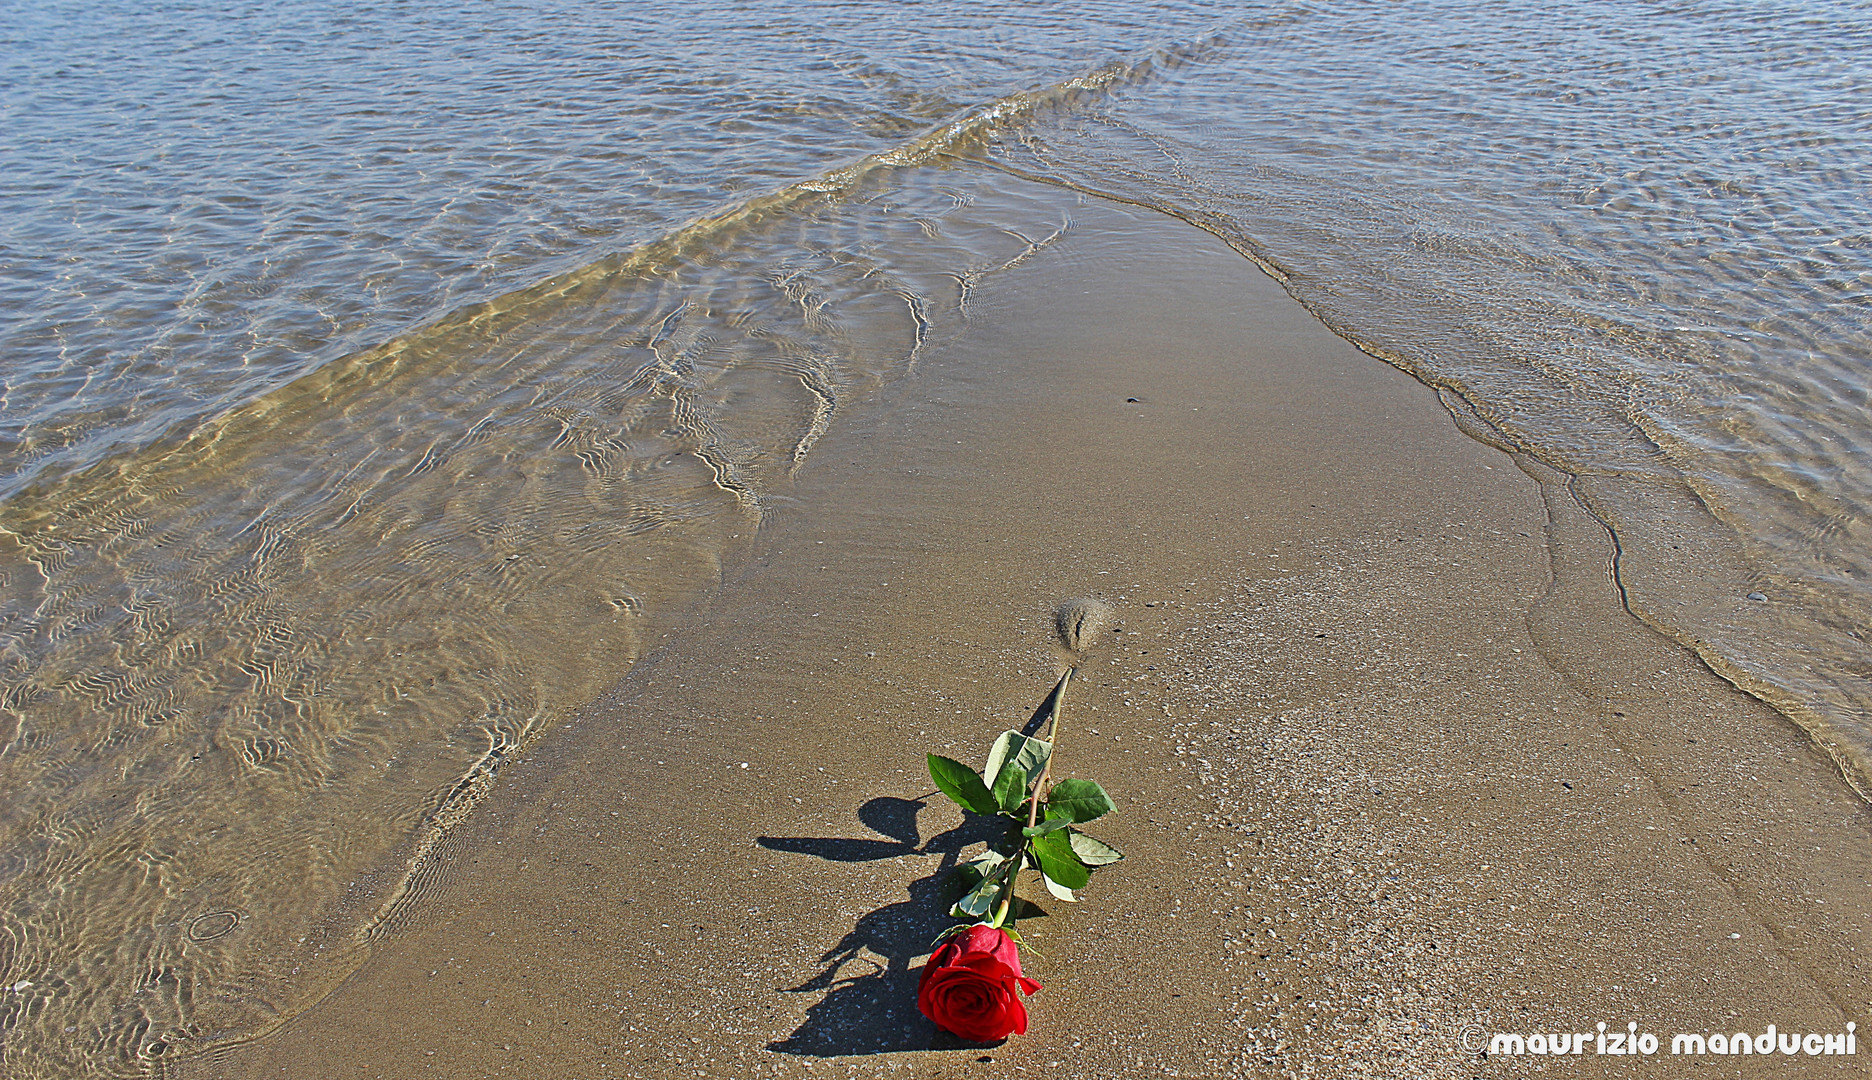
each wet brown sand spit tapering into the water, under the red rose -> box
[178,204,1872,1078]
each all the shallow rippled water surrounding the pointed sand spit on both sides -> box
[0,4,1872,1076]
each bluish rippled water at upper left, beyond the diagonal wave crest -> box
[0,0,1221,496]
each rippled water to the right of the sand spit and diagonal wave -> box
[994,2,1872,795]
